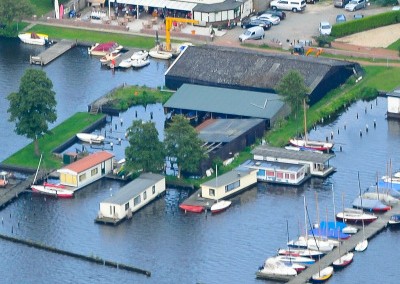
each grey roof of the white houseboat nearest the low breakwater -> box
[102,173,165,205]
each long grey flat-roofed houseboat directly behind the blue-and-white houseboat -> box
[252,145,336,177]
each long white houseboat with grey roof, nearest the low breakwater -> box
[96,173,166,224]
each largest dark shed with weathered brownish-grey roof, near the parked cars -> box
[165,45,362,105]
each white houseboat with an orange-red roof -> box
[57,151,114,190]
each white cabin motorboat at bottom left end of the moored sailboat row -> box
[257,258,297,282]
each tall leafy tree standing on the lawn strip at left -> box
[7,69,57,156]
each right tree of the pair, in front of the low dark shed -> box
[164,115,206,178]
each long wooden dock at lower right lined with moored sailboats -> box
[287,205,400,284]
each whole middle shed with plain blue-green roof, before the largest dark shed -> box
[164,84,289,128]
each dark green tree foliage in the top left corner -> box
[0,0,34,26]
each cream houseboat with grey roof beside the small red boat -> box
[200,167,257,200]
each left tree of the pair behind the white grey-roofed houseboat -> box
[125,120,165,172]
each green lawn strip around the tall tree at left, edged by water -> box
[3,112,104,169]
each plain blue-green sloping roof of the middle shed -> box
[164,84,284,119]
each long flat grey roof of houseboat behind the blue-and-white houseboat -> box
[251,145,335,164]
